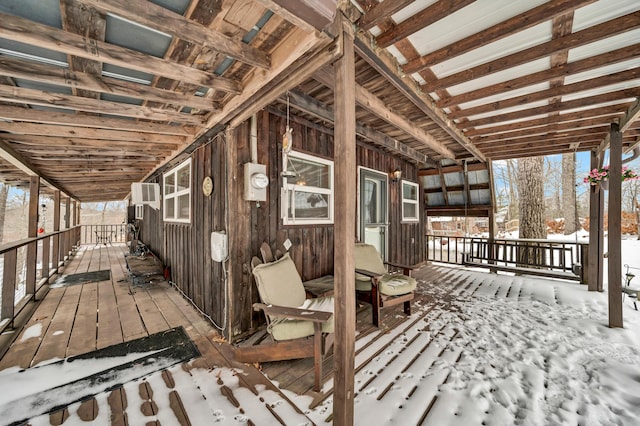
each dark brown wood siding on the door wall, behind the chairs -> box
[225,111,424,335]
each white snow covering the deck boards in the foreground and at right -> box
[0,239,640,426]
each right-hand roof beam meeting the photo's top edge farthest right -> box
[402,0,596,74]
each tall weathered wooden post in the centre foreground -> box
[333,16,357,426]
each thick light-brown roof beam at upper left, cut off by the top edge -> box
[79,0,271,69]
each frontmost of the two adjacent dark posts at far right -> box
[608,123,624,327]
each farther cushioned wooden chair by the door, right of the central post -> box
[354,243,416,327]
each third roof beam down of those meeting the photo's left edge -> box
[0,84,203,125]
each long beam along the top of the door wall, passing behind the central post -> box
[288,91,434,165]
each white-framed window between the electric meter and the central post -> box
[281,151,333,225]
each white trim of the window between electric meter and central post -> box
[280,151,335,226]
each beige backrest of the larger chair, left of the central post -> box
[253,253,306,308]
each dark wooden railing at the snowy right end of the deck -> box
[427,235,589,282]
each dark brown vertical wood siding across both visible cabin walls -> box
[141,111,425,338]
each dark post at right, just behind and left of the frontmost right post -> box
[585,150,604,291]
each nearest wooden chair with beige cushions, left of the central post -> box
[235,253,333,392]
